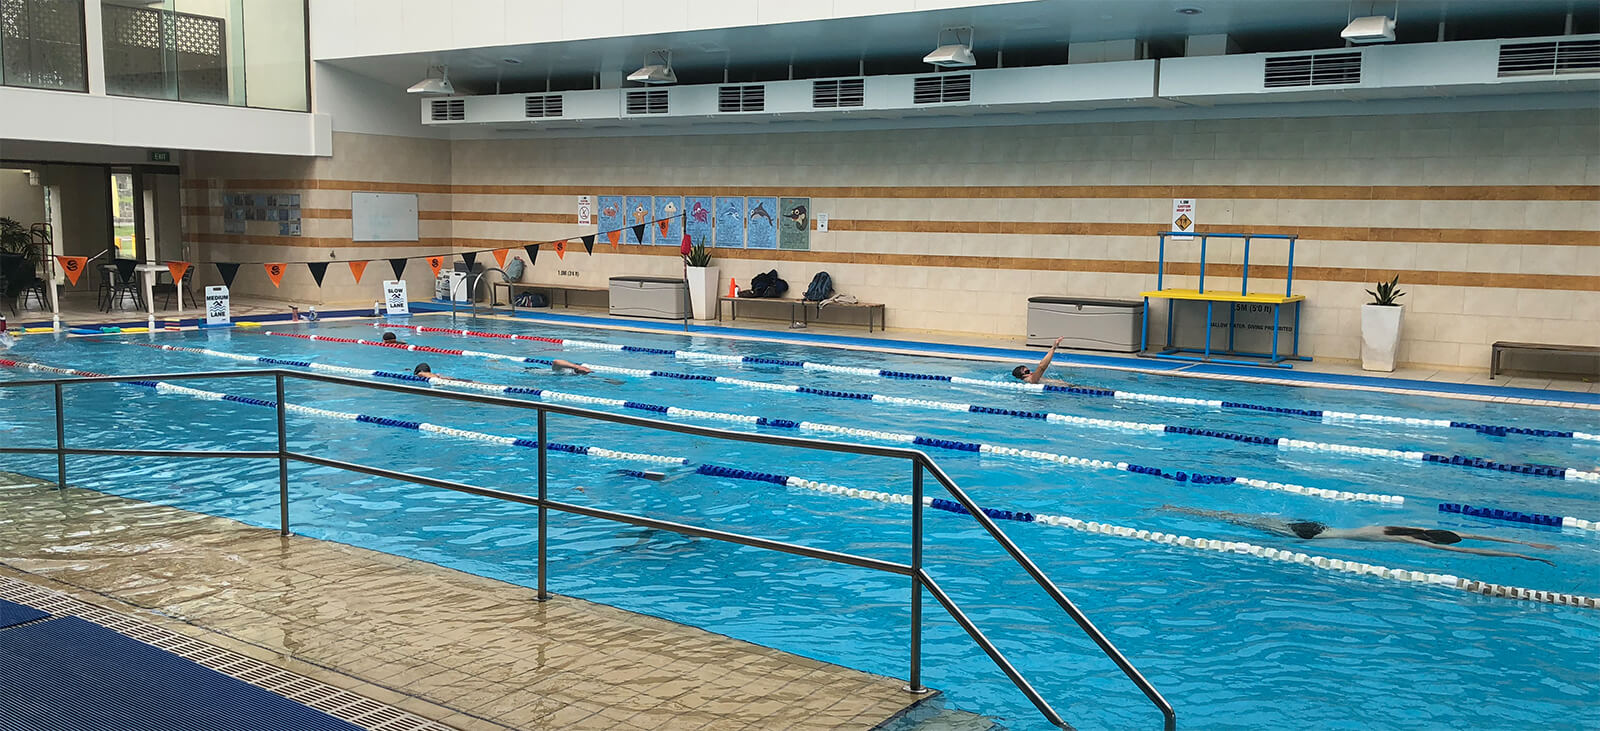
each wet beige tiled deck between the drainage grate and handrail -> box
[0,472,923,729]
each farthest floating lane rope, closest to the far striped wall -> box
[368,323,1600,441]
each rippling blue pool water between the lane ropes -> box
[0,318,1600,729]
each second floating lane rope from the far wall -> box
[270,328,1600,481]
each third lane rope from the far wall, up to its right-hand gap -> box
[140,342,1405,505]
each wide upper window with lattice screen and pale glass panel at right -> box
[104,0,309,112]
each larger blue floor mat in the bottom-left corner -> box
[0,617,358,731]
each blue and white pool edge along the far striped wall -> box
[400,302,1600,409]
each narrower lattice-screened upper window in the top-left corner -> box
[0,0,88,91]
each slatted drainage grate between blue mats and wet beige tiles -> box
[0,576,451,731]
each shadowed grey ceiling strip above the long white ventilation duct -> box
[325,0,1600,93]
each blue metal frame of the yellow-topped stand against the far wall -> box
[1139,230,1310,368]
